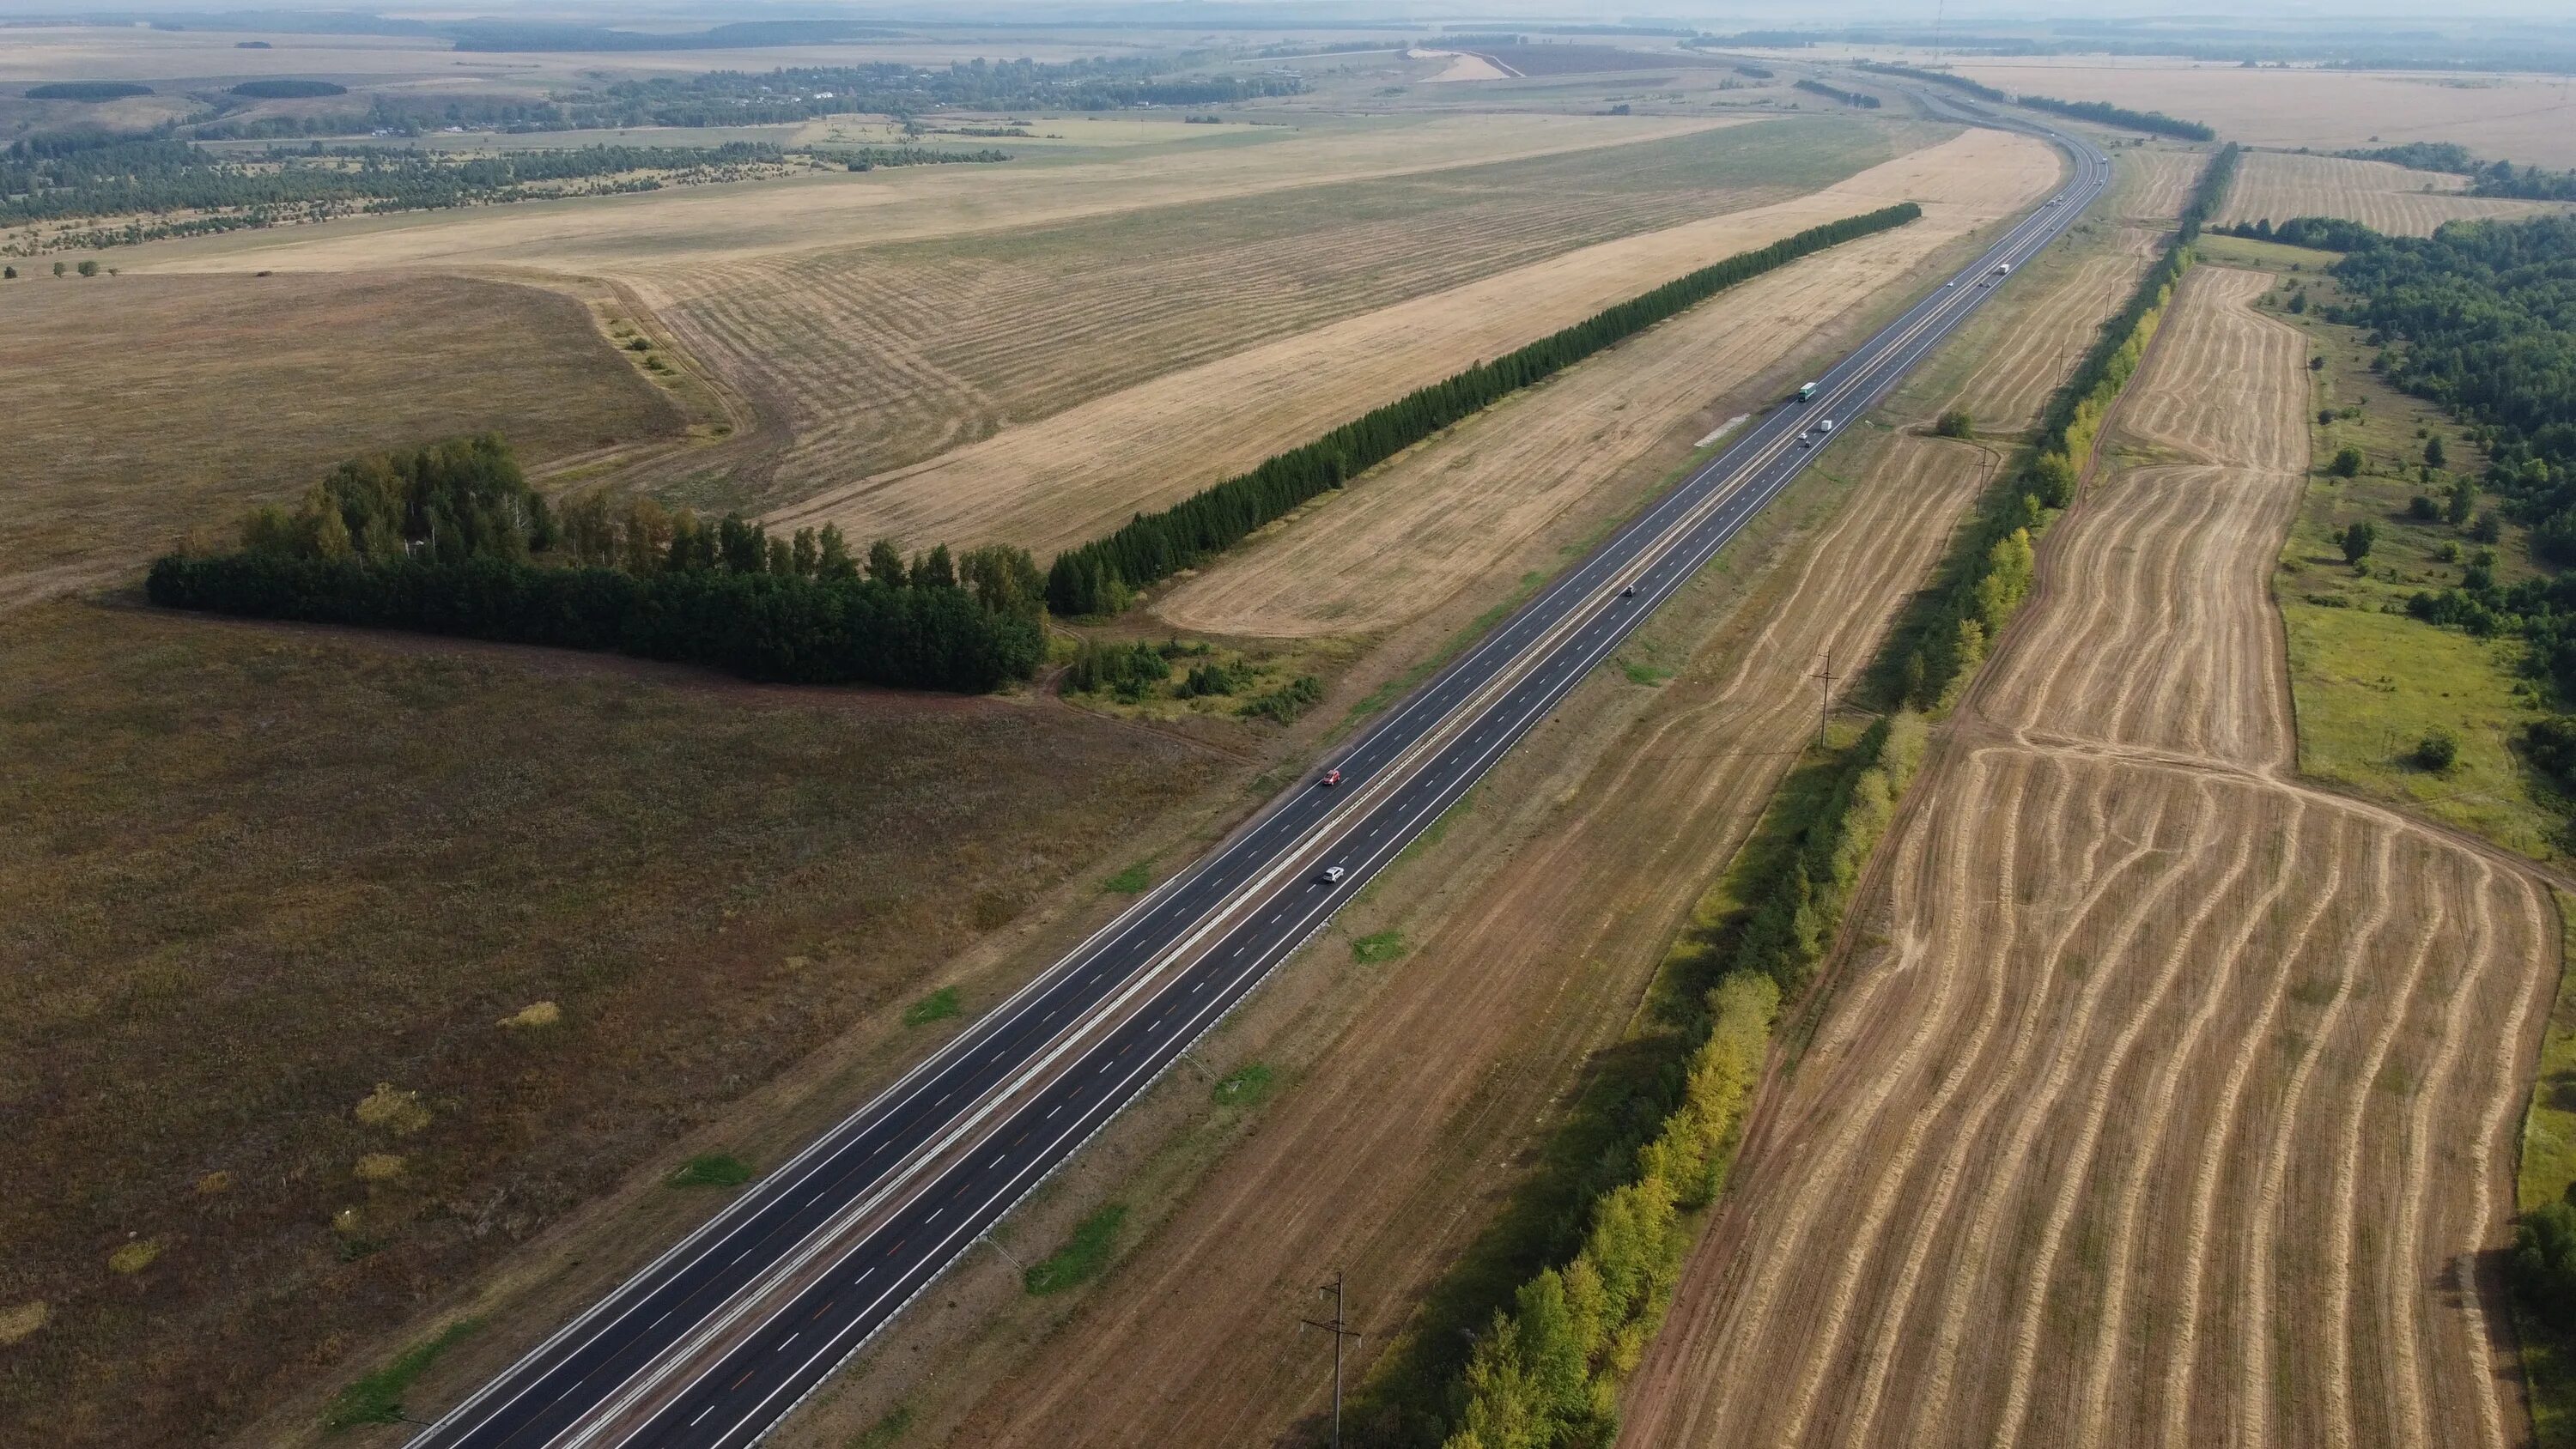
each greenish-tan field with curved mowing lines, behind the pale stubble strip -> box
[647,118,1896,502]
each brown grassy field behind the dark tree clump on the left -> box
[0,270,680,608]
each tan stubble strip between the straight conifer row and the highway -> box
[1154,227,1989,636]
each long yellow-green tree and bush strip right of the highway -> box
[1365,147,2236,1449]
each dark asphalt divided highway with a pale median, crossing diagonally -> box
[412,98,2110,1449]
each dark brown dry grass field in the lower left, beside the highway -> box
[0,603,1208,1446]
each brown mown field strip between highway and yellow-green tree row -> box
[917,435,1981,1444]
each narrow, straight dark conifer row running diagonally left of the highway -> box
[1046,201,1922,615]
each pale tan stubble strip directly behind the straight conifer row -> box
[770,131,2058,554]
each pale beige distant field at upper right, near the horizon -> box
[1958,57,2576,167]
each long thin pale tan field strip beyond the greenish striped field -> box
[121,116,1744,278]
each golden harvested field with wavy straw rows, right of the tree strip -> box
[1623,268,2558,1446]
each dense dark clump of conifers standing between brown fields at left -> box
[147,435,1046,693]
